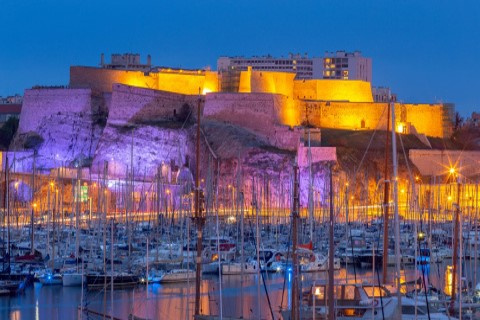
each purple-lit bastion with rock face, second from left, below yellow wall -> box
[92,84,198,177]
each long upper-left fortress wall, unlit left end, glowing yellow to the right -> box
[70,67,219,94]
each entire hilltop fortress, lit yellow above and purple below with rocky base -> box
[3,57,453,212]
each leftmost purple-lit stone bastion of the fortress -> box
[13,88,102,168]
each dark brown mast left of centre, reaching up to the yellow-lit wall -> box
[194,88,205,316]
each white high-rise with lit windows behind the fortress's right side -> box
[313,51,372,83]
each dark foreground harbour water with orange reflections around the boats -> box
[0,261,480,320]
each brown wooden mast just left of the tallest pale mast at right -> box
[382,99,395,283]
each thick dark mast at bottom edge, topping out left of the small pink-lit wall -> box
[290,159,300,320]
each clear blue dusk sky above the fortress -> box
[0,0,480,116]
